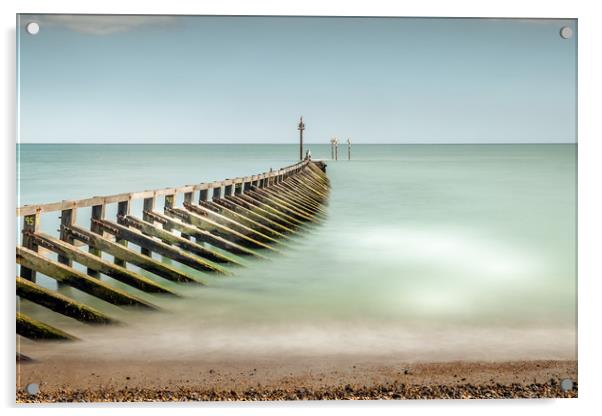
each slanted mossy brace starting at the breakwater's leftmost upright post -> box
[35,231,177,296]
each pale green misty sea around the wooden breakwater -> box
[18,145,577,360]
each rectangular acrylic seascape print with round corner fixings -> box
[16,14,578,402]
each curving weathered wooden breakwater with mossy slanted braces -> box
[16,158,329,341]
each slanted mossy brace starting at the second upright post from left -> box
[69,227,195,282]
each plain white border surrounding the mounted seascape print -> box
[0,0,602,416]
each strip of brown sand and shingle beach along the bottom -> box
[17,355,577,402]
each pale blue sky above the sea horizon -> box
[17,15,577,143]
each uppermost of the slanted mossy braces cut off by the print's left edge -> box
[17,247,157,309]
